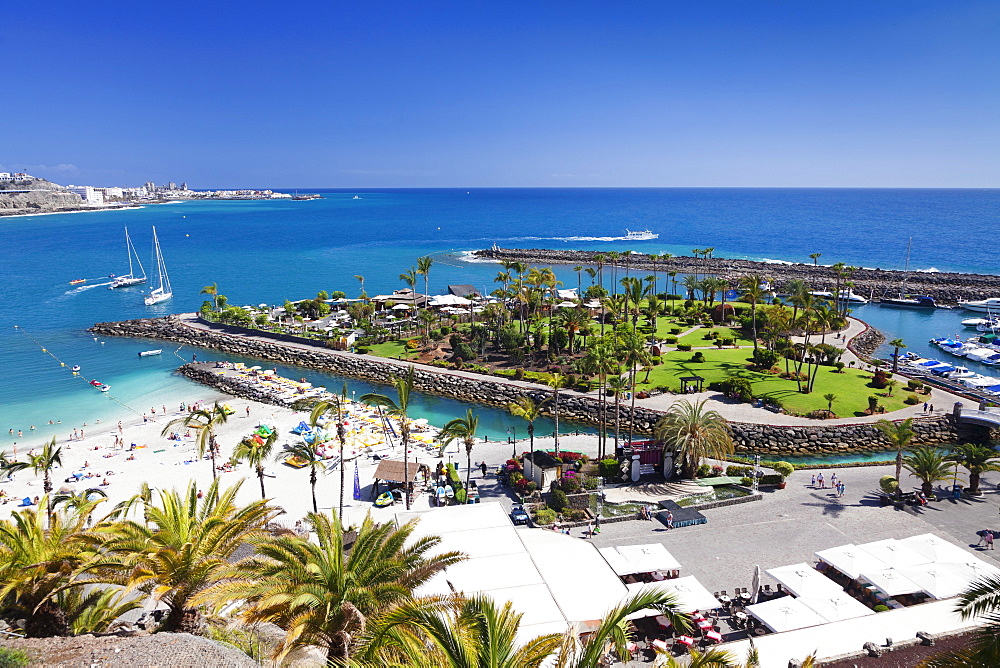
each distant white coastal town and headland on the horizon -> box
[0,172,308,216]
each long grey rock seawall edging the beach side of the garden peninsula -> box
[90,316,959,455]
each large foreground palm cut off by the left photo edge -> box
[0,499,93,638]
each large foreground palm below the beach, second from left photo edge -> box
[87,481,281,633]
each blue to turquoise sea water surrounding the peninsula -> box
[0,189,1000,447]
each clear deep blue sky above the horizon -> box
[0,0,1000,188]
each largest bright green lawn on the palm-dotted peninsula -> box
[638,348,909,417]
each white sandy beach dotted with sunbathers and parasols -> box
[0,388,597,526]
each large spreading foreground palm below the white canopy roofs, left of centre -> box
[229,513,464,665]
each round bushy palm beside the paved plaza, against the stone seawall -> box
[656,399,735,478]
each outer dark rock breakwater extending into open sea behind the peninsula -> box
[476,248,1000,304]
